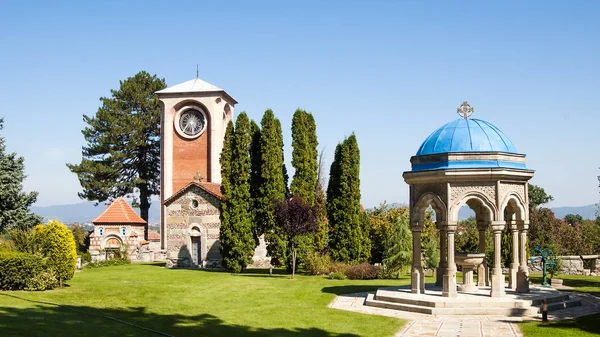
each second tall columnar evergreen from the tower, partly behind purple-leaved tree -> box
[256,110,287,265]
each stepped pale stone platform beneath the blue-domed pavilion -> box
[365,284,581,317]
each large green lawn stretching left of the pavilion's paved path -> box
[0,264,410,337]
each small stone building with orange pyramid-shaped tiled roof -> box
[89,198,160,262]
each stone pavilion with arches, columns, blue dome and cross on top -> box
[403,102,533,297]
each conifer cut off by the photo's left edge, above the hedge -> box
[0,118,42,232]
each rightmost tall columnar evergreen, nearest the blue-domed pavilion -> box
[327,134,370,262]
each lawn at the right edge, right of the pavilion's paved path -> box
[519,274,600,337]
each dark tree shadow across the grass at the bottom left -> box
[0,295,358,337]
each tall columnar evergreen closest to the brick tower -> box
[220,112,255,272]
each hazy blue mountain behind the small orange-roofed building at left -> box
[31,200,160,224]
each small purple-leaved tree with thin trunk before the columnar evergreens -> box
[275,196,318,279]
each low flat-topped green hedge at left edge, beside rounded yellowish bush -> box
[0,252,46,290]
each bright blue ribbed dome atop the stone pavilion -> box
[417,118,517,156]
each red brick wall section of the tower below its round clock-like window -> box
[173,125,210,193]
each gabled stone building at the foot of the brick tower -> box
[163,181,221,268]
